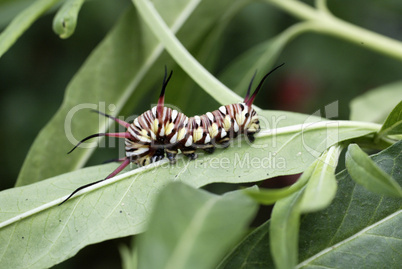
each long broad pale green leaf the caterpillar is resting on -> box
[0,121,377,268]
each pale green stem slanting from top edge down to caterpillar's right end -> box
[132,0,243,104]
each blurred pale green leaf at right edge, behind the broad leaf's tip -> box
[350,81,402,123]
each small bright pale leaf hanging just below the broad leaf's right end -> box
[301,145,342,213]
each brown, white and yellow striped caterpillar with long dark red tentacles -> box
[60,64,284,205]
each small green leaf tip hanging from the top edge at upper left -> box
[53,0,85,38]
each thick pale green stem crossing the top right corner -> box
[266,0,402,60]
